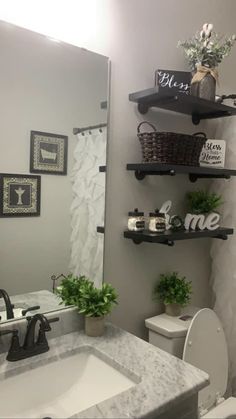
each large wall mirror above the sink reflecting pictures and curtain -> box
[0,22,109,322]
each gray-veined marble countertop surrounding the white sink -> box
[0,324,209,419]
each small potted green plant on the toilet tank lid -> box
[153,272,192,316]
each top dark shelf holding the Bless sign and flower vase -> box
[129,87,236,125]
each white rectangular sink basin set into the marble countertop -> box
[0,347,139,419]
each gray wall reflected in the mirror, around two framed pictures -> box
[0,24,108,294]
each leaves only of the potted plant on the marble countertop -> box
[78,281,118,317]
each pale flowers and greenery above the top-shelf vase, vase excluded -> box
[178,23,236,71]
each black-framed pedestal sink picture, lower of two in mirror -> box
[0,173,41,217]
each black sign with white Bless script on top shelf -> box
[155,70,192,95]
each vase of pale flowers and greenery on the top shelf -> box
[178,23,236,101]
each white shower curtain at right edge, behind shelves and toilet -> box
[211,117,236,395]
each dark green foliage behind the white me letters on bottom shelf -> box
[186,190,223,214]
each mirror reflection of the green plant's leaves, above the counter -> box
[56,274,91,306]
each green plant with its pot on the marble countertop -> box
[78,281,118,336]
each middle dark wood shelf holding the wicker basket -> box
[127,163,236,182]
